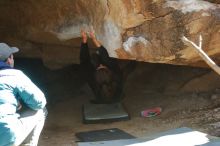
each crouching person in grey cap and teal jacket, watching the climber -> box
[0,43,47,146]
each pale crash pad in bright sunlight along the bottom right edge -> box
[77,127,220,146]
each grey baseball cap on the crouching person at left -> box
[0,43,19,61]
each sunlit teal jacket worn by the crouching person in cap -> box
[0,62,46,146]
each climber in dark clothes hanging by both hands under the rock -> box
[80,30,123,104]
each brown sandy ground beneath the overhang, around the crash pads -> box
[40,93,220,146]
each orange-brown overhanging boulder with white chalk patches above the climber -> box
[0,0,220,69]
